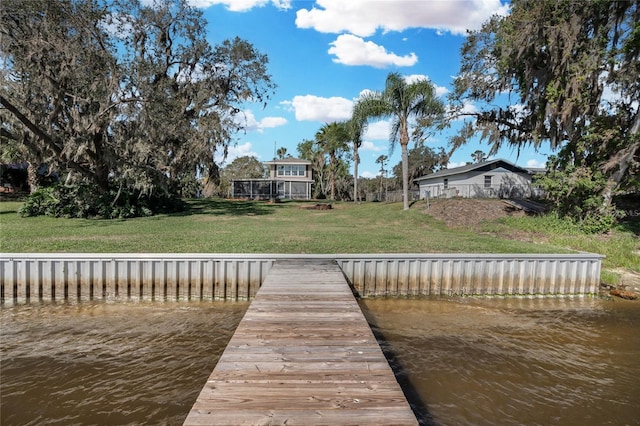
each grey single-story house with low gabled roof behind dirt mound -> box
[414,159,542,199]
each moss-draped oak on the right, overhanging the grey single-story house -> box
[451,0,640,230]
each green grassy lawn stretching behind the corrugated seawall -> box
[0,200,640,271]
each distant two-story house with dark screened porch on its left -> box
[232,157,313,200]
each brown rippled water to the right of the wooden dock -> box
[361,299,640,425]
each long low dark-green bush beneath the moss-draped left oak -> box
[18,183,184,219]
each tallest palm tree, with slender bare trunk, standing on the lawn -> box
[355,72,444,210]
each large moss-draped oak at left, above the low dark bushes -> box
[0,0,275,216]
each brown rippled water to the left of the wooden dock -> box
[0,302,248,425]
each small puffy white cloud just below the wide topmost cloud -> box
[329,34,418,68]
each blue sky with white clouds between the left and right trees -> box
[191,0,548,177]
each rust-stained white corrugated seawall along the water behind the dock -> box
[0,253,603,304]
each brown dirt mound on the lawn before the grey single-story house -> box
[425,198,525,227]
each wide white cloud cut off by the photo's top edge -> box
[296,0,509,37]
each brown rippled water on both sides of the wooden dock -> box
[0,299,640,425]
